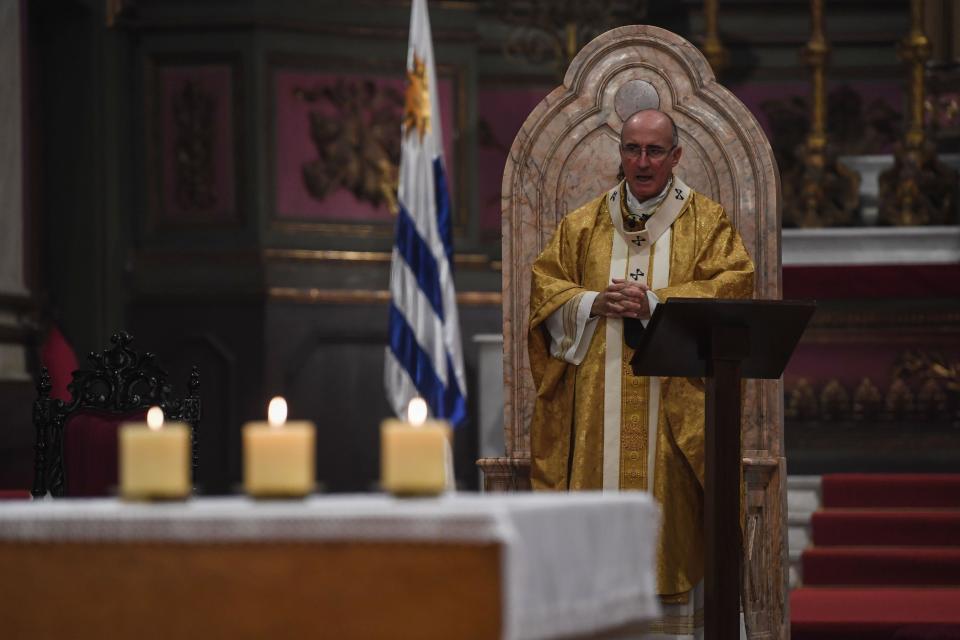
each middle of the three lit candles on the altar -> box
[243,397,316,498]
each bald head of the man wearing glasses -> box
[620,109,683,202]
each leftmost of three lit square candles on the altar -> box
[119,407,190,500]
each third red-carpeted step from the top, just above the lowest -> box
[803,547,960,587]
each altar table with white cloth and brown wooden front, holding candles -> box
[0,493,659,639]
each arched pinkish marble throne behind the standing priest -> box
[479,25,789,638]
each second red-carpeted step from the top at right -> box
[811,509,960,547]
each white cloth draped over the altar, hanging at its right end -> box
[0,493,659,639]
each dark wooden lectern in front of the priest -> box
[624,298,816,640]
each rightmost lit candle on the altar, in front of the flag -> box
[380,398,453,495]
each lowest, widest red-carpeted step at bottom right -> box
[790,587,960,640]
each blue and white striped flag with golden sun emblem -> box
[384,0,467,425]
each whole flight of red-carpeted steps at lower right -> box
[790,474,960,640]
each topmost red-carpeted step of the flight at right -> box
[820,473,960,509]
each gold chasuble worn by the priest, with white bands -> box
[528,177,753,603]
